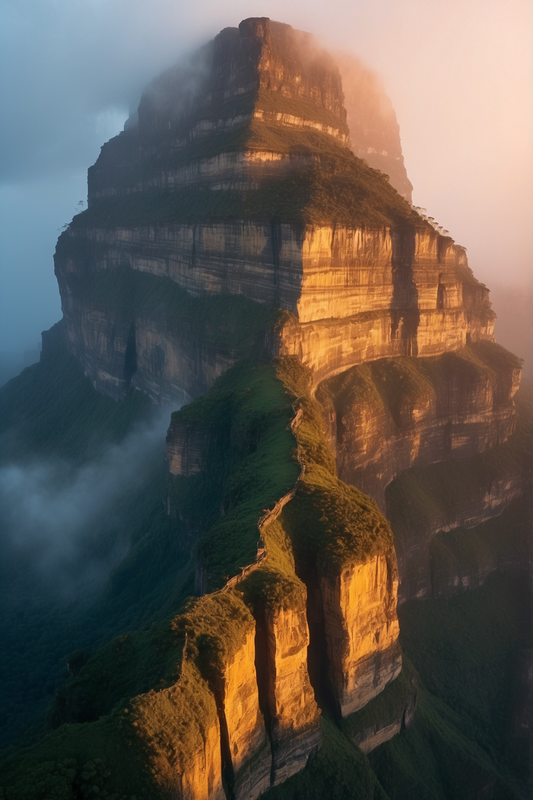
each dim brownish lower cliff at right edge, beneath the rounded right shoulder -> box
[386,440,529,602]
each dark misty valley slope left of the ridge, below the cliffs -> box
[0,347,194,746]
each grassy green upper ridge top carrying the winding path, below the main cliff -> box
[171,358,392,588]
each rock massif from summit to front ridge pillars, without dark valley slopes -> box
[6,12,527,800]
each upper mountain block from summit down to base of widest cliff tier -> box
[56,19,493,402]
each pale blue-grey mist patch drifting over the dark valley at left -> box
[0,409,170,599]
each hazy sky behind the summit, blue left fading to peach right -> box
[0,0,533,351]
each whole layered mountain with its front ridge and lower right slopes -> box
[0,18,533,800]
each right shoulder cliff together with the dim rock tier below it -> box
[317,342,528,601]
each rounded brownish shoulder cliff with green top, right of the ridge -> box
[318,342,521,506]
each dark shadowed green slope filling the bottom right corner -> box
[370,573,531,800]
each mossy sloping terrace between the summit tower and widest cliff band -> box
[72,124,422,231]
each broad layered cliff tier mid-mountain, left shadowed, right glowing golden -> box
[56,222,493,402]
